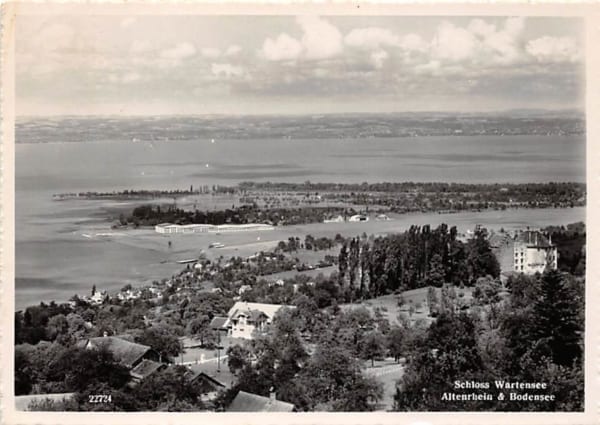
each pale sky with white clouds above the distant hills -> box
[15,15,585,116]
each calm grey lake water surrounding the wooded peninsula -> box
[15,136,585,308]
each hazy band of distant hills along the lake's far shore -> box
[15,109,585,143]
